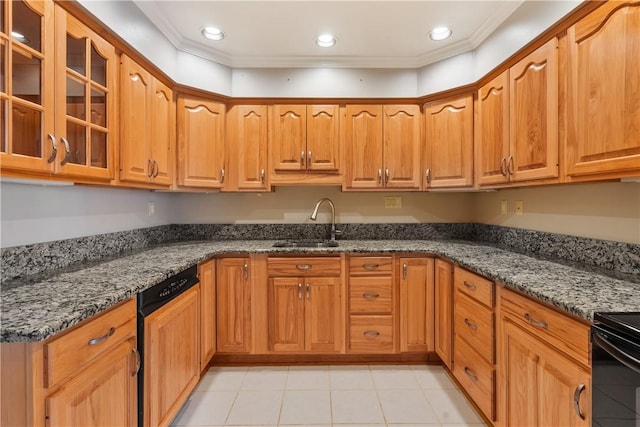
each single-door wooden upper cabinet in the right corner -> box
[424,94,473,188]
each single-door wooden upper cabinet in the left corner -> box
[178,96,226,188]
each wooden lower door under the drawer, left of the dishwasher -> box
[46,338,138,427]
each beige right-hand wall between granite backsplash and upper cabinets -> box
[474,182,640,243]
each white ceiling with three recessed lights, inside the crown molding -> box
[134,0,524,68]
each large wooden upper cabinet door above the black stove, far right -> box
[565,1,640,179]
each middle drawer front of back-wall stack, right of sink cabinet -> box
[349,276,393,314]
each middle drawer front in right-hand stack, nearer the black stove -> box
[454,291,495,363]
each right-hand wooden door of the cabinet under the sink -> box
[304,277,344,353]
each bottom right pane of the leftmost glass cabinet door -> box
[11,102,42,157]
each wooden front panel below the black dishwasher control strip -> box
[144,286,200,427]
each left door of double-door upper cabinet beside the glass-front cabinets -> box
[119,55,153,182]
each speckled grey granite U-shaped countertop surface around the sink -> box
[0,240,640,342]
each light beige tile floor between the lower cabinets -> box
[172,365,485,427]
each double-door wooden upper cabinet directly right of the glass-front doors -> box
[119,55,175,186]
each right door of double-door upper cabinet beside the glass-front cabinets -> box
[149,78,176,186]
